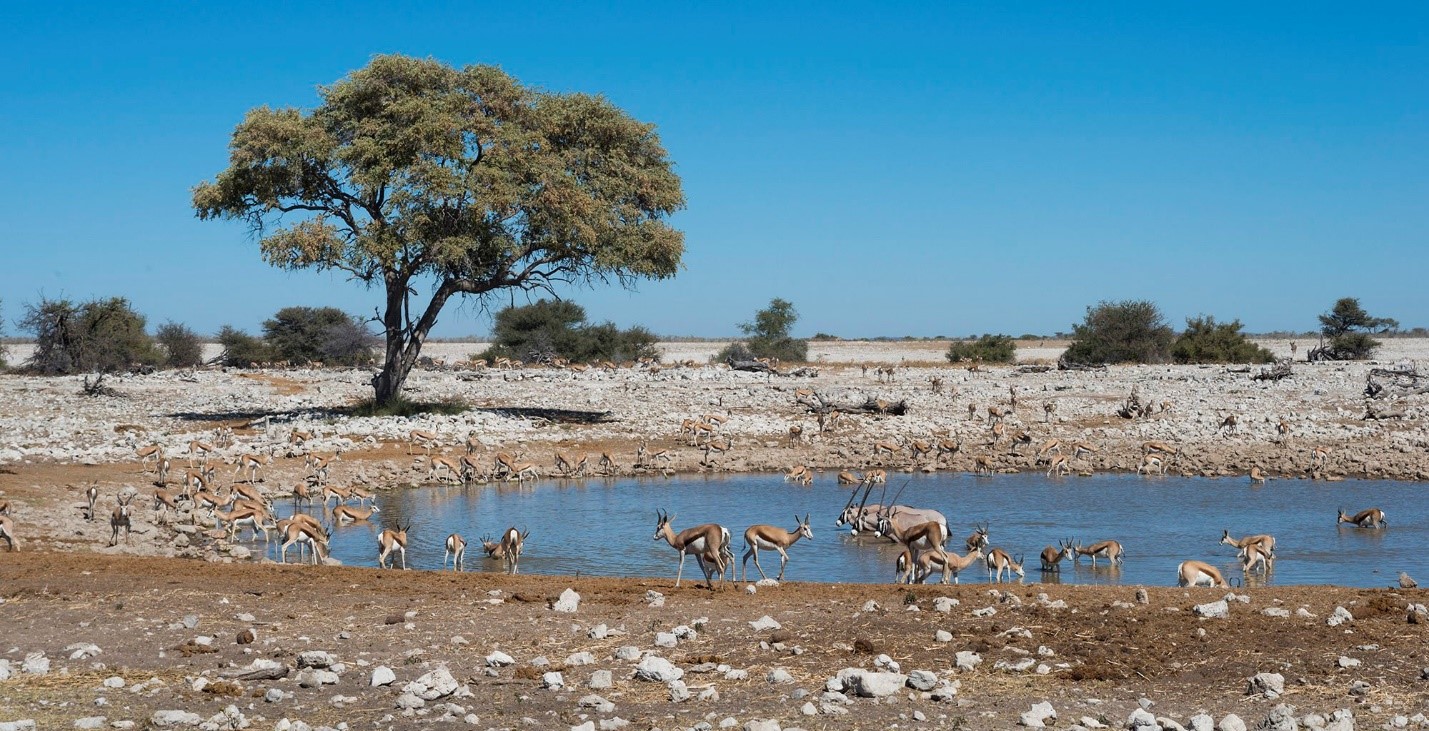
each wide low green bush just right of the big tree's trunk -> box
[479,300,659,363]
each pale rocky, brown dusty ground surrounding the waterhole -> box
[0,340,1429,728]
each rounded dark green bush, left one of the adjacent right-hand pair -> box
[1062,300,1176,364]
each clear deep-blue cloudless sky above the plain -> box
[0,0,1429,337]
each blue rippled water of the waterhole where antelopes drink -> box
[260,473,1429,587]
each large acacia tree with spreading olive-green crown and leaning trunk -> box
[193,56,684,404]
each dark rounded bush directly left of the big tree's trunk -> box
[263,307,377,366]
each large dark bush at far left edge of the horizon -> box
[20,297,160,375]
